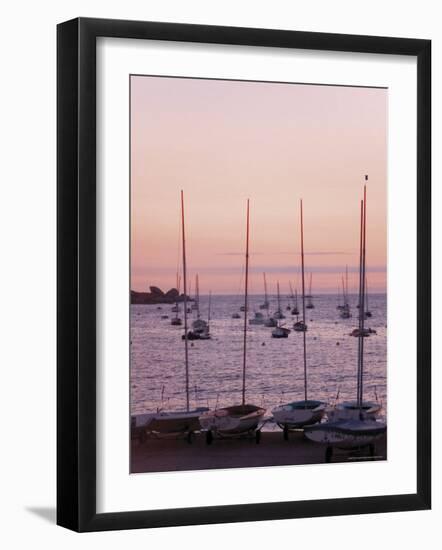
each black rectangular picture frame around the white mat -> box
[57,18,431,531]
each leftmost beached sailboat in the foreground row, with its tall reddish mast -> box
[136,191,208,443]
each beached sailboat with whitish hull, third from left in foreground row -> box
[272,200,326,439]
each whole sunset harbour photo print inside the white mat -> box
[129,75,388,473]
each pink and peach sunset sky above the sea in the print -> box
[130,76,388,294]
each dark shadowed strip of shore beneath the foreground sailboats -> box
[131,432,387,473]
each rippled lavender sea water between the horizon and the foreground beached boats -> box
[131,294,387,424]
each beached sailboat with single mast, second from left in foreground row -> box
[200,200,265,444]
